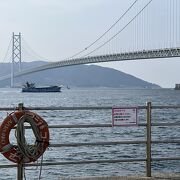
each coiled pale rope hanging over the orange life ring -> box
[16,114,43,160]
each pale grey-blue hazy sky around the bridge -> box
[0,0,180,88]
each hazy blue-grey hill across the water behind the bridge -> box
[0,61,160,88]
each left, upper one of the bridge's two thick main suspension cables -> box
[67,0,138,59]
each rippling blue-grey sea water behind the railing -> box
[0,88,180,180]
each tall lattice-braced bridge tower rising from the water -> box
[11,32,21,87]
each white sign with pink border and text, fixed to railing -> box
[112,107,137,126]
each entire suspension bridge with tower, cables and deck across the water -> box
[0,0,180,86]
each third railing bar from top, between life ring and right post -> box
[49,141,146,147]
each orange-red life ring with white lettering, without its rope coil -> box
[0,111,49,163]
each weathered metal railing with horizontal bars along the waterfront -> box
[0,102,180,179]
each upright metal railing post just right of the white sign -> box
[146,102,152,177]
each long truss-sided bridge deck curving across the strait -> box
[0,47,180,80]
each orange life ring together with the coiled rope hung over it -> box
[0,111,49,163]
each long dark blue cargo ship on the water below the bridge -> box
[22,82,61,93]
